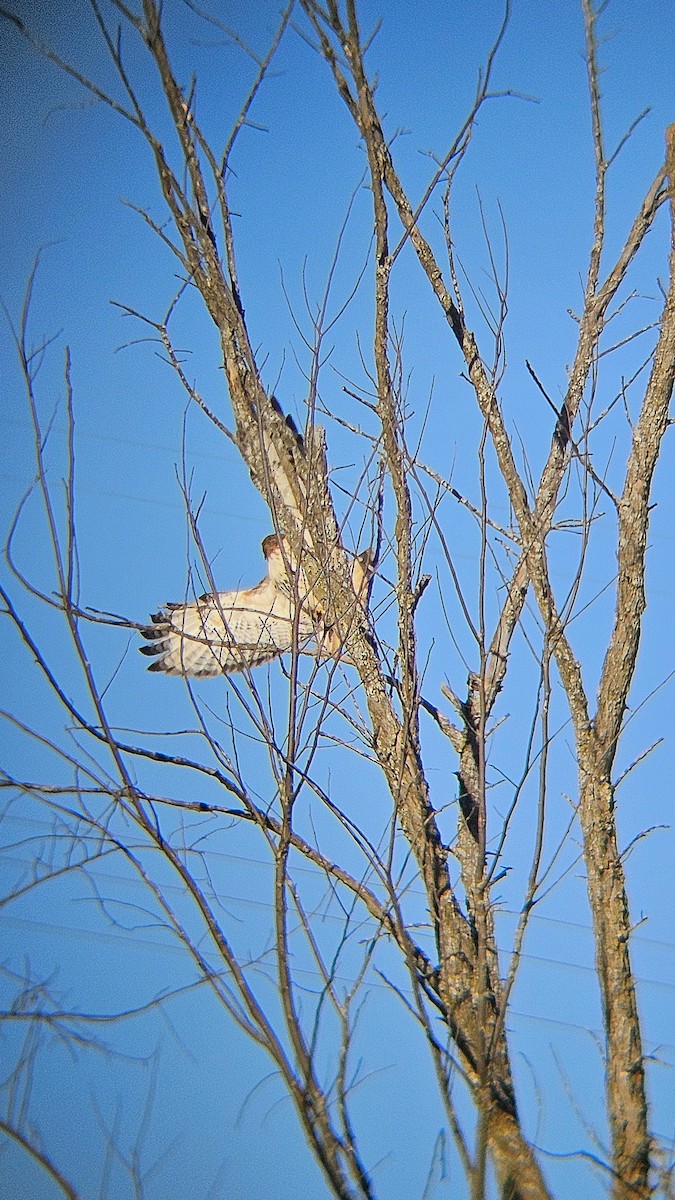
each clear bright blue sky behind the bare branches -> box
[0,0,675,1200]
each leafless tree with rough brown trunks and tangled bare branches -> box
[2,0,675,1200]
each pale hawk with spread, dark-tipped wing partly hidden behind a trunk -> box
[141,534,371,676]
